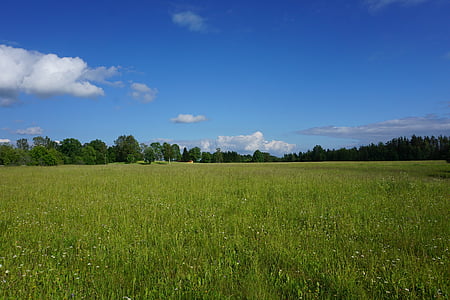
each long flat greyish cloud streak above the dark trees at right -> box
[298,115,450,142]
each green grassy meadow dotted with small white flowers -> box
[0,162,450,299]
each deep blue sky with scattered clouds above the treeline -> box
[0,0,450,156]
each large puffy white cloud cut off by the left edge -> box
[0,45,118,106]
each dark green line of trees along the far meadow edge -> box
[0,135,450,166]
